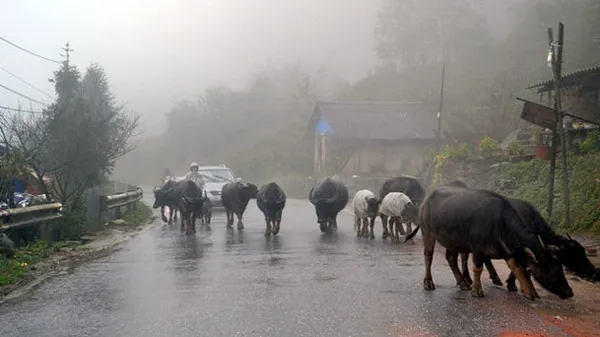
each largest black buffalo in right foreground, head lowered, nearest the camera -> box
[406,186,573,300]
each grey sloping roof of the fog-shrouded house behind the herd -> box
[305,102,437,140]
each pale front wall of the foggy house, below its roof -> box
[342,141,434,175]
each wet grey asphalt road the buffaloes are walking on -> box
[0,192,568,337]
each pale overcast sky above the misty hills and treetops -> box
[0,0,379,133]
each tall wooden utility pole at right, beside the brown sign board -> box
[548,22,571,227]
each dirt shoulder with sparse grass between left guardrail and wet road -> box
[0,215,157,304]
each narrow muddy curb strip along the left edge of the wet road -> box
[0,214,157,305]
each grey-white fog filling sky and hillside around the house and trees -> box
[0,0,600,182]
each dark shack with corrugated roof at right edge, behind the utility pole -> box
[527,65,600,125]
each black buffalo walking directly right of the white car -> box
[221,182,258,230]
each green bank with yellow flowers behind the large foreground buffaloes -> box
[432,131,600,234]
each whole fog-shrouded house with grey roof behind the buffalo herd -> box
[305,102,437,175]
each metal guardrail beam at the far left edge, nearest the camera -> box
[0,202,62,232]
